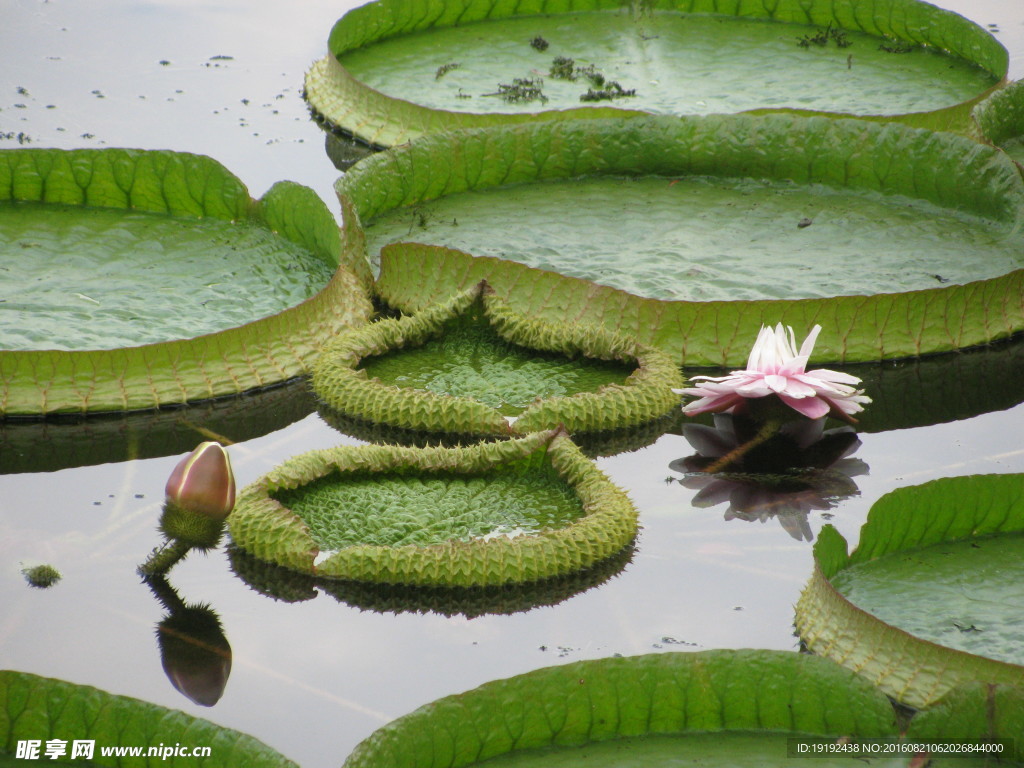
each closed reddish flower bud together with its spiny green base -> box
[160,442,234,549]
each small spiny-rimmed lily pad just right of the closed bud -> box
[228,430,637,587]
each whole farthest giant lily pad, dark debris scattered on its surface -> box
[306,0,1007,146]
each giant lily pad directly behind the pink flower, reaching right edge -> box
[337,116,1024,367]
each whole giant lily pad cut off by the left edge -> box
[0,150,371,416]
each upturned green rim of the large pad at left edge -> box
[0,147,372,418]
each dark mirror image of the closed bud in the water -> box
[157,605,231,707]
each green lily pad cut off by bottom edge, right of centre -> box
[344,650,896,768]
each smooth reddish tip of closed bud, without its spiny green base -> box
[167,441,234,520]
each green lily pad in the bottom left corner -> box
[0,670,296,768]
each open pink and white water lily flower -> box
[673,323,871,421]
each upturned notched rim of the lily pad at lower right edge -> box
[796,474,1024,709]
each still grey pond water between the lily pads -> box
[0,0,1024,768]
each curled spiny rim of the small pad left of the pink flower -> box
[312,282,683,436]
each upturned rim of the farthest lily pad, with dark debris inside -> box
[304,0,1009,148]
